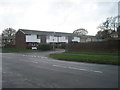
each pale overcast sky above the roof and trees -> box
[0,0,119,35]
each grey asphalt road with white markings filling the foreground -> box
[2,51,118,88]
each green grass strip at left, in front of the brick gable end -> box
[0,48,38,53]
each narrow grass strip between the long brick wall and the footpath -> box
[64,51,120,56]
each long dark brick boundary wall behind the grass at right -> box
[67,40,120,51]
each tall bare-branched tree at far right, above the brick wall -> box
[96,16,119,39]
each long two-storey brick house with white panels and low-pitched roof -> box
[16,29,80,49]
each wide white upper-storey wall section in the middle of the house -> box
[46,36,68,43]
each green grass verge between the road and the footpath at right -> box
[49,53,118,65]
